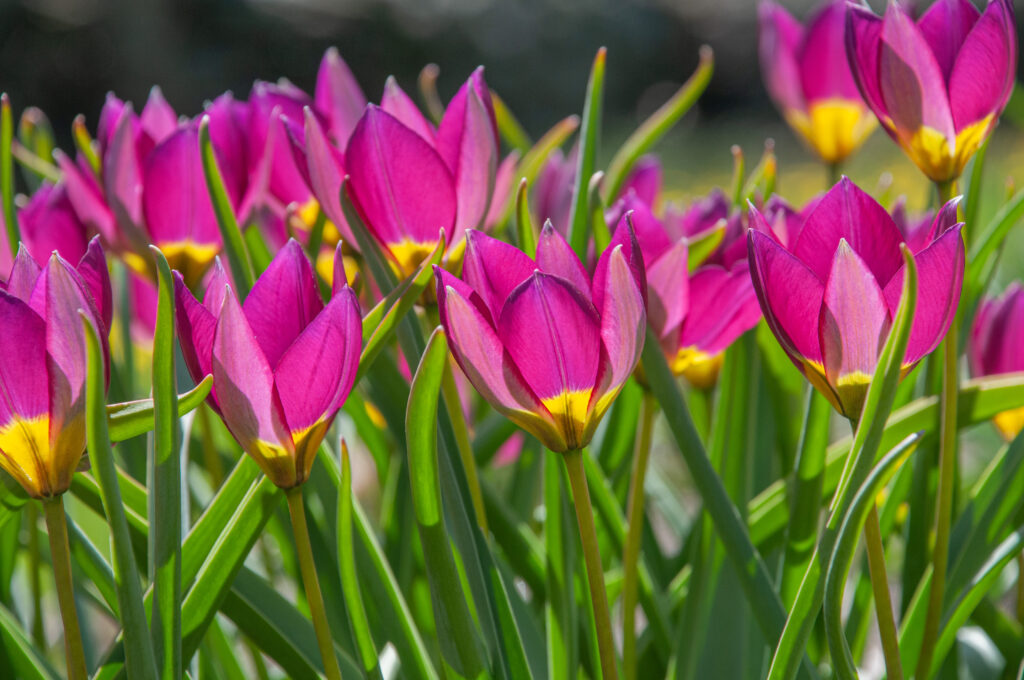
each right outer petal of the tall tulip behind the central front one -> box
[436,71,498,235]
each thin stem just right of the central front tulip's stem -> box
[623,390,657,680]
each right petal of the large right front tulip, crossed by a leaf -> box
[885,224,964,366]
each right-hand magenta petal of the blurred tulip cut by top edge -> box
[798,0,860,103]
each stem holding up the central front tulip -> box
[562,449,618,680]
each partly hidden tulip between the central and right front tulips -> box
[611,193,761,388]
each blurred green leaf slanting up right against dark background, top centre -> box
[604,45,715,201]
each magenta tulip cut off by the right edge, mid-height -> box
[968,282,1024,440]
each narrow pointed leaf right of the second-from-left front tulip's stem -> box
[337,439,381,679]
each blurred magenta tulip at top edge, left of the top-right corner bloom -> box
[759,0,877,163]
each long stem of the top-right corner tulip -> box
[915,181,959,680]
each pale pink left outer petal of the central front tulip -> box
[434,267,566,451]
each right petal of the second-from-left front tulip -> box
[273,286,362,436]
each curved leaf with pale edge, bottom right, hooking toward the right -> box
[824,433,921,678]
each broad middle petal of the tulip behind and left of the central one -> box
[345,105,456,251]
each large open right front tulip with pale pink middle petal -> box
[748,178,964,420]
